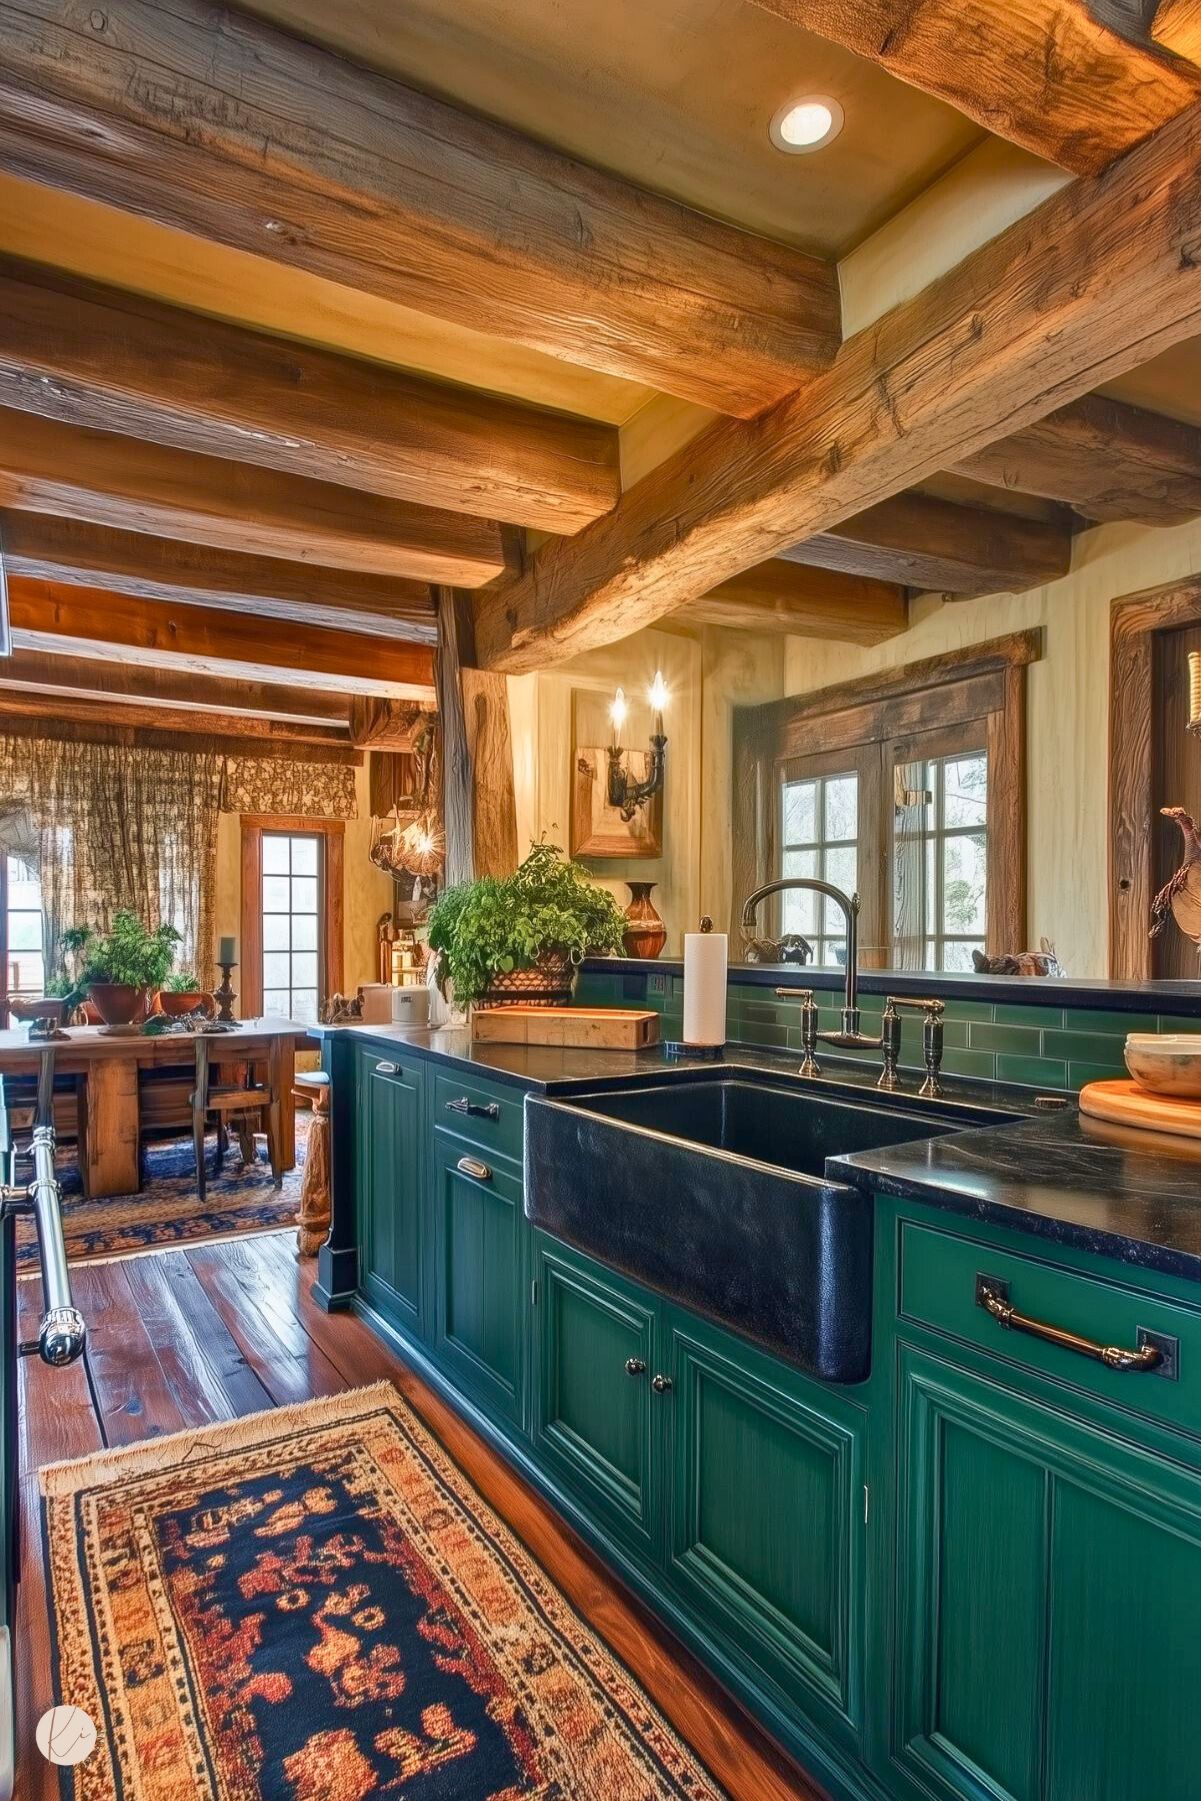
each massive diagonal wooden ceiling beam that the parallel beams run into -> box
[475,110,1201,672]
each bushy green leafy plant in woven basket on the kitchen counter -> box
[429,843,625,1007]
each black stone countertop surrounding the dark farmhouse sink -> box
[313,1025,1201,1282]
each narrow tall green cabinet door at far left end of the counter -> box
[355,1045,427,1338]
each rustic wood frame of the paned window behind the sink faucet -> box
[729,629,1043,956]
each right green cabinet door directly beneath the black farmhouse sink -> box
[670,1311,866,1729]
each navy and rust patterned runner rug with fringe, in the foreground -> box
[41,1383,722,1801]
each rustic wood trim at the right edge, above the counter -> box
[1109,576,1201,982]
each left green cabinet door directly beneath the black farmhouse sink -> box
[535,1237,663,1551]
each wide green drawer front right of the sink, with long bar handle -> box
[897,1216,1201,1435]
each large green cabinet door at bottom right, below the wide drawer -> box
[893,1347,1201,1801]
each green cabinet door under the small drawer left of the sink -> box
[434,1129,529,1426]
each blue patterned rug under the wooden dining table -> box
[16,1111,312,1273]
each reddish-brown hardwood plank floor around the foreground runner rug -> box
[16,1232,819,1801]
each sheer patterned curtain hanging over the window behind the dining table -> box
[0,738,223,985]
